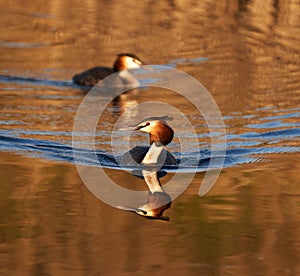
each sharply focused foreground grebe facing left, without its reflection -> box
[121,116,177,165]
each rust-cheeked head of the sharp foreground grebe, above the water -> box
[135,117,174,146]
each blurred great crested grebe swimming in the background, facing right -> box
[72,53,144,86]
